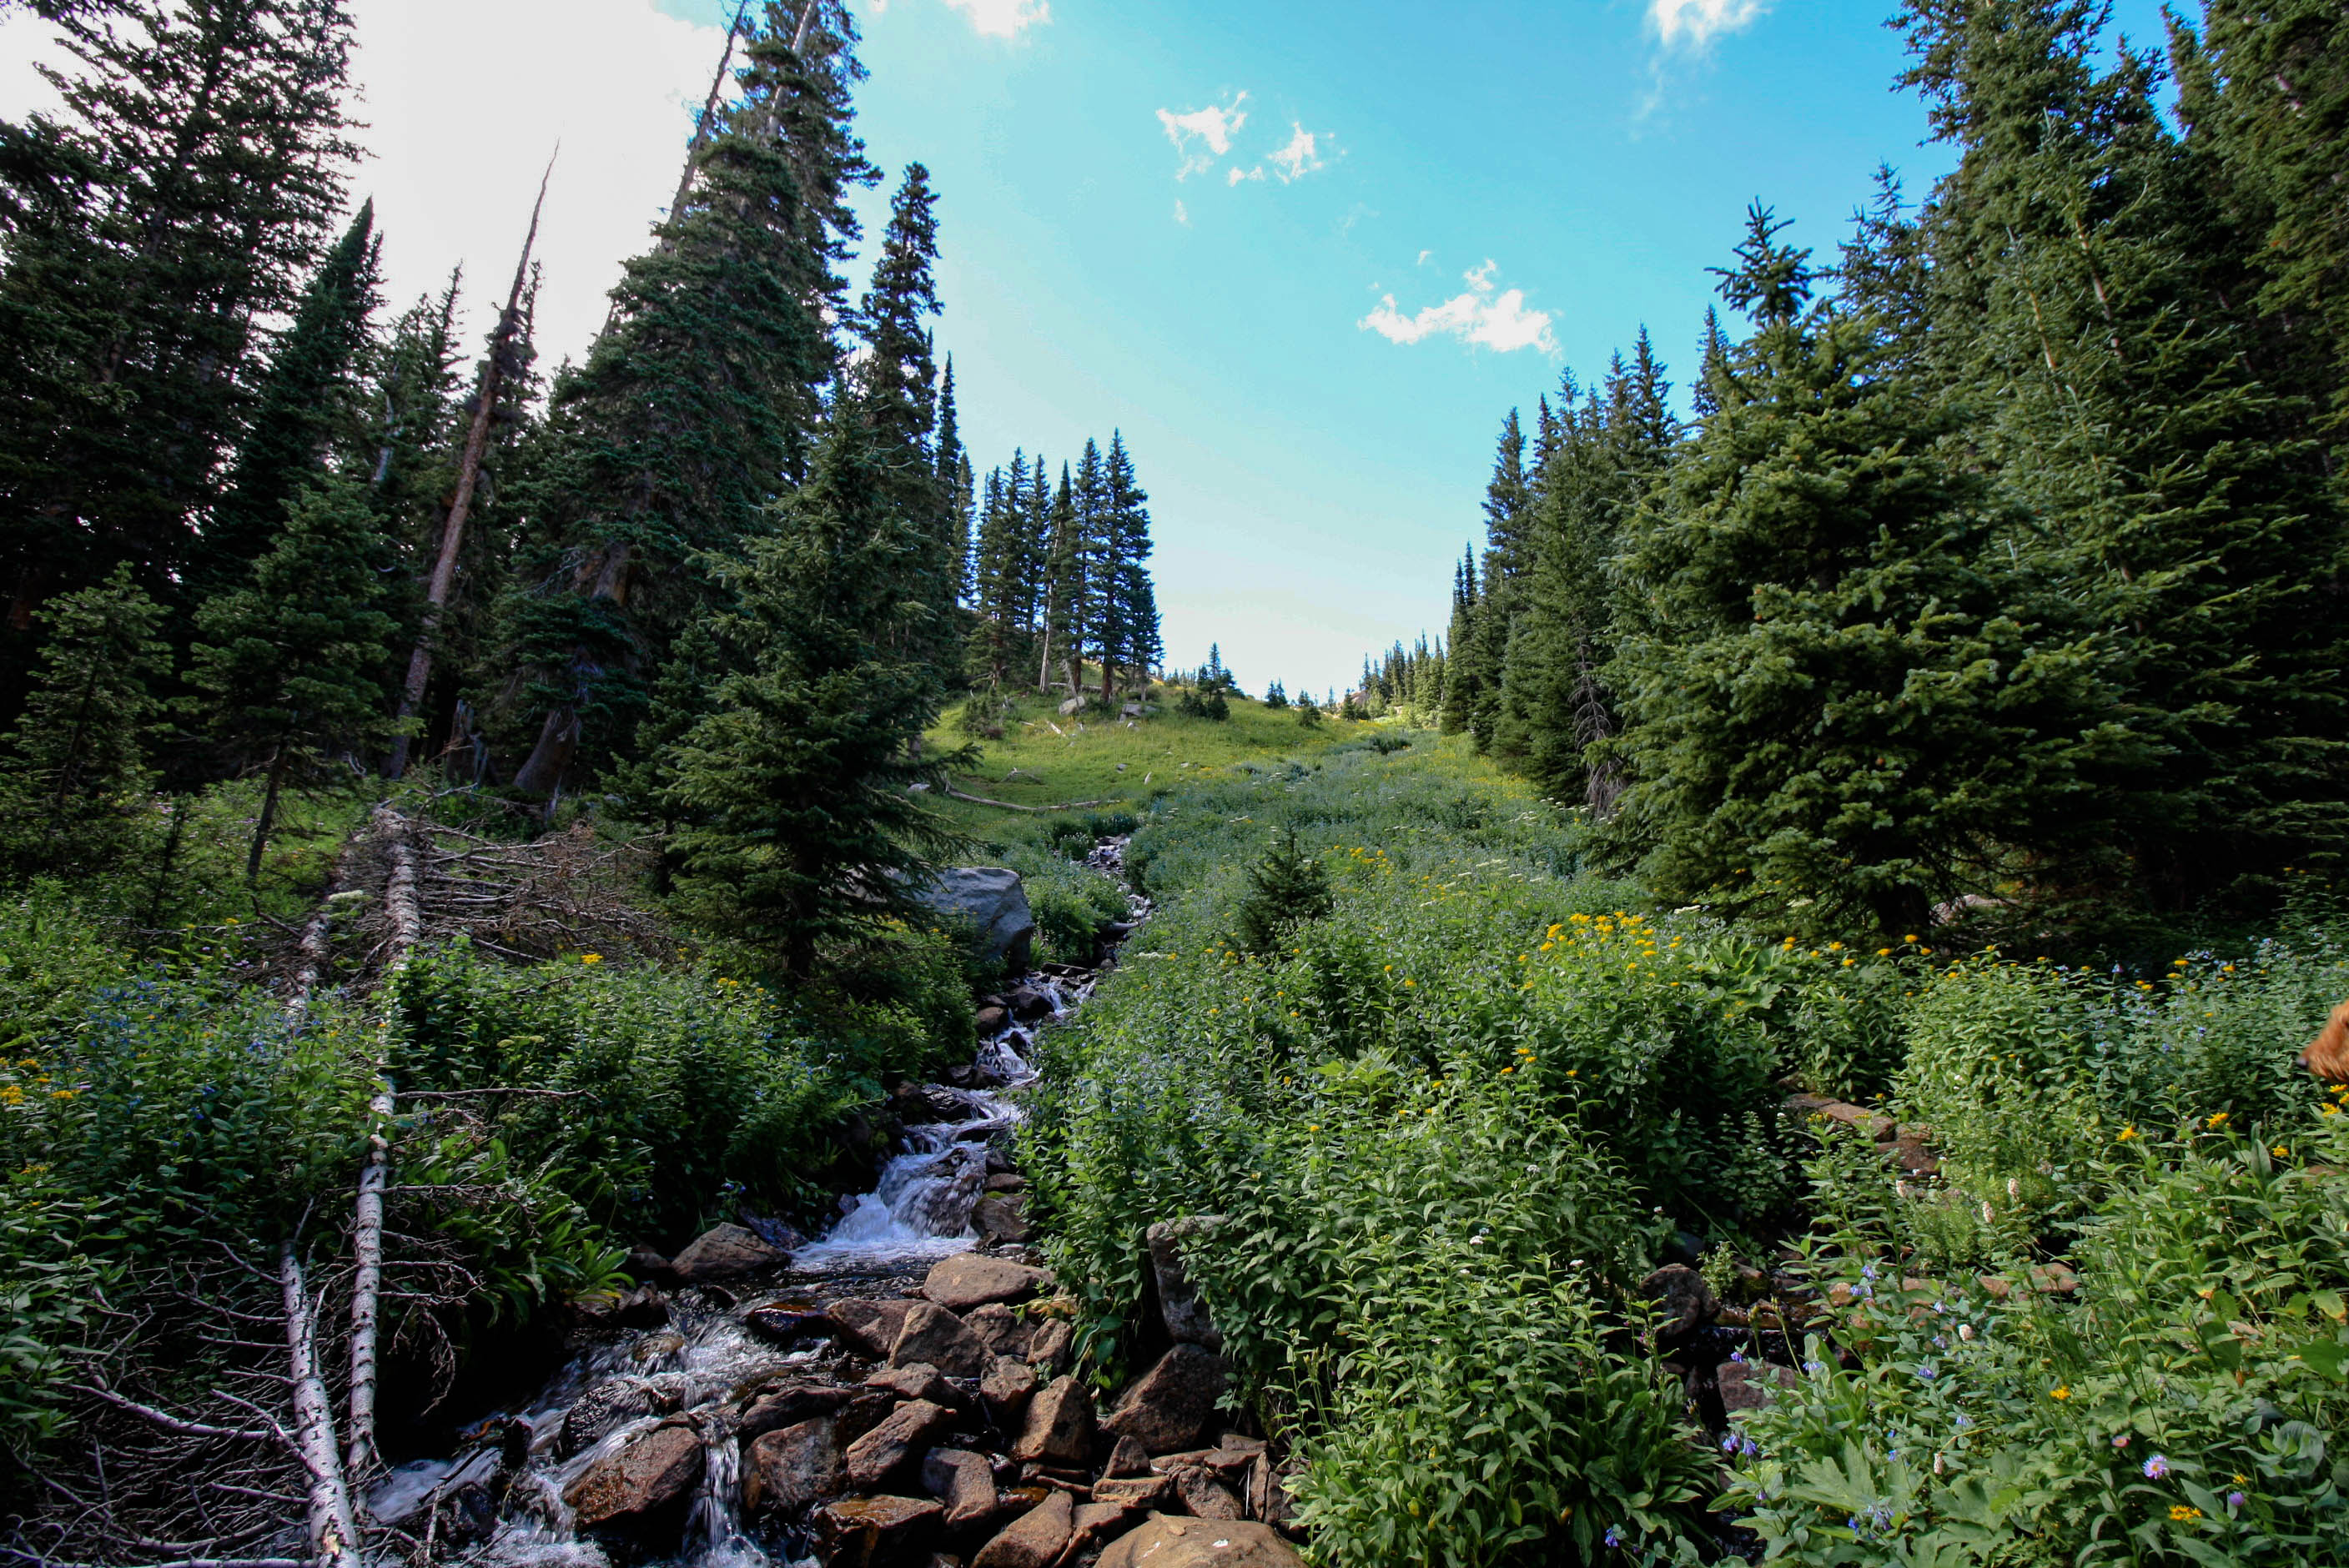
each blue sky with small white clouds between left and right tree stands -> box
[704,0,2159,690]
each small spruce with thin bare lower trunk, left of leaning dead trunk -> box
[181,476,397,882]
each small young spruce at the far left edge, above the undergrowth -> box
[0,563,172,876]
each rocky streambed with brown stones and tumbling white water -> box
[369,841,1299,1568]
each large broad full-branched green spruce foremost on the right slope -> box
[1609,207,2147,937]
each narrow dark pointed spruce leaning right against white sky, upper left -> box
[195,202,383,591]
